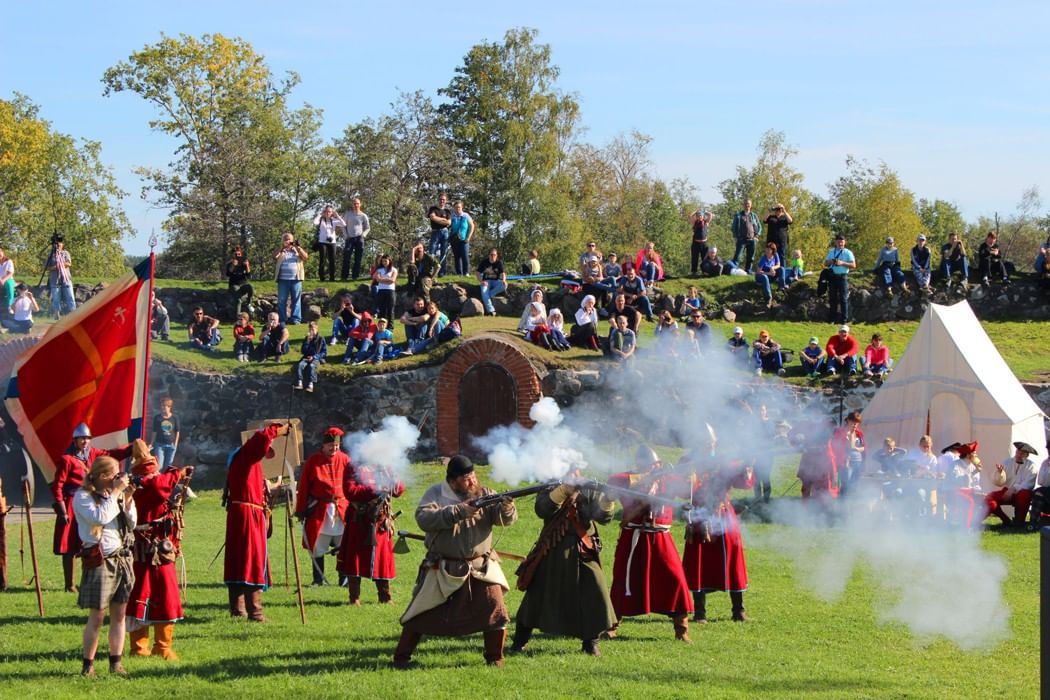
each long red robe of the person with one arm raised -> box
[223,425,280,589]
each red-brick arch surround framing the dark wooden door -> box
[437,335,543,457]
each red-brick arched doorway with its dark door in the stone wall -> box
[437,334,543,457]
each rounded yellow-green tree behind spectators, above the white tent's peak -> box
[828,155,926,269]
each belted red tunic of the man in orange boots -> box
[128,469,183,624]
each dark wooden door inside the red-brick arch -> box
[459,362,518,462]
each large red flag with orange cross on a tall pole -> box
[4,255,153,481]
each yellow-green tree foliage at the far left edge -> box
[0,96,131,279]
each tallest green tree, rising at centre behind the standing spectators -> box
[439,29,579,260]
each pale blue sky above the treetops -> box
[0,0,1050,253]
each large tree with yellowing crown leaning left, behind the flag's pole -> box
[103,34,320,275]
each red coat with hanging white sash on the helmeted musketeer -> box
[609,472,693,617]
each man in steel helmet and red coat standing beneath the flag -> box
[51,423,131,593]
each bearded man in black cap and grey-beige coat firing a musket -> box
[394,454,518,669]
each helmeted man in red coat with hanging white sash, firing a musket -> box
[609,445,693,642]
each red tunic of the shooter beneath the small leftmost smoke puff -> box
[336,465,404,580]
